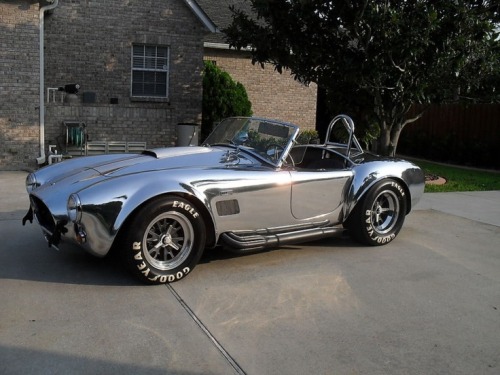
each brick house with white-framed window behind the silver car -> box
[0,0,316,170]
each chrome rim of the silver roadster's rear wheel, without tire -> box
[370,190,399,234]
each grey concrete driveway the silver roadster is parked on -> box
[0,172,500,375]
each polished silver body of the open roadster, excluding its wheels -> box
[25,116,424,257]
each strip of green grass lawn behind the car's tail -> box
[406,158,500,193]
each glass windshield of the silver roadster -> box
[204,117,299,166]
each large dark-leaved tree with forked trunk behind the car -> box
[223,0,500,155]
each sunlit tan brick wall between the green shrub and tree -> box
[205,48,317,129]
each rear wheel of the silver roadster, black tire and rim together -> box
[345,180,406,246]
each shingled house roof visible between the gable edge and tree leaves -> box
[184,0,252,48]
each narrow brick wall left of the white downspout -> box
[0,1,39,170]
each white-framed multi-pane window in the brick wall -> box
[130,43,170,99]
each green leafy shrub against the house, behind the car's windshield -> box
[201,61,252,140]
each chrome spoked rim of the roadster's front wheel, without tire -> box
[142,211,194,271]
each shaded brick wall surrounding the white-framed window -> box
[45,0,206,156]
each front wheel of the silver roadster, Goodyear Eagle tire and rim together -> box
[122,197,206,284]
